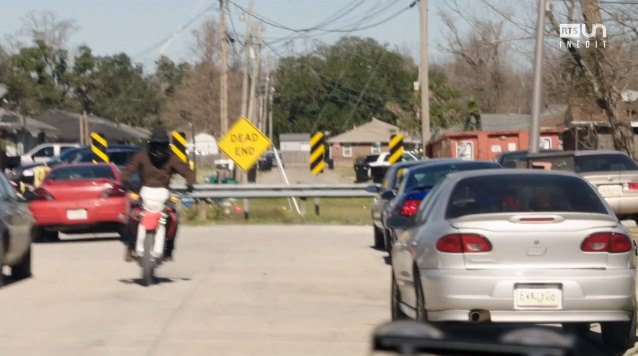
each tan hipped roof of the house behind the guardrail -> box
[328,118,420,144]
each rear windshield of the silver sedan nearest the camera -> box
[446,174,607,219]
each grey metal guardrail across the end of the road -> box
[171,184,375,219]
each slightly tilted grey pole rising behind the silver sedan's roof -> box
[529,0,546,153]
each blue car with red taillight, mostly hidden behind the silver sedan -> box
[382,159,503,252]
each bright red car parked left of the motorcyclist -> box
[29,163,129,241]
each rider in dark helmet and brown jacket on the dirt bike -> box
[121,128,195,262]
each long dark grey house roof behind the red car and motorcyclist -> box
[38,110,150,141]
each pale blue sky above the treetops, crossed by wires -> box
[0,0,458,71]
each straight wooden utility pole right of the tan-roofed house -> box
[419,0,430,156]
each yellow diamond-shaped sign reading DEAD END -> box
[218,116,272,172]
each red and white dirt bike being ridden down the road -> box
[129,193,189,286]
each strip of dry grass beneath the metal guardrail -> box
[181,198,372,225]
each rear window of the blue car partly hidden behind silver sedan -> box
[403,162,501,192]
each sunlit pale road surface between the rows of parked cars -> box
[0,226,636,356]
